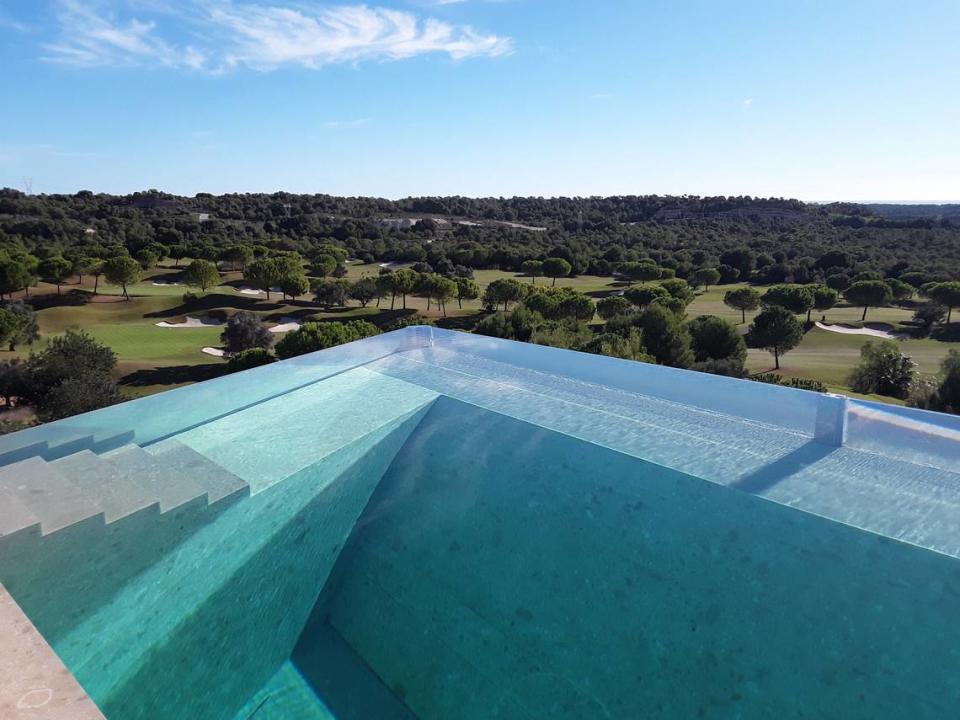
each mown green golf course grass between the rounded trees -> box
[0,263,957,401]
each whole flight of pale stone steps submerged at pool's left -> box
[0,436,249,543]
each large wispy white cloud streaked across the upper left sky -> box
[46,0,513,72]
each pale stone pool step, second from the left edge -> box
[0,457,103,534]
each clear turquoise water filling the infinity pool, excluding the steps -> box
[0,330,960,720]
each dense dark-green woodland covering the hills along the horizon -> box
[0,189,960,283]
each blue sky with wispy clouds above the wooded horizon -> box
[0,0,960,201]
